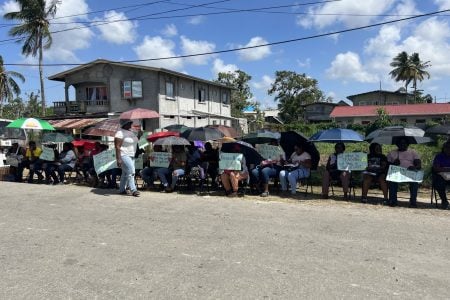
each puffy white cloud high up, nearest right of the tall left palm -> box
[94,10,137,45]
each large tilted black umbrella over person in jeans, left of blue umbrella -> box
[280,131,320,170]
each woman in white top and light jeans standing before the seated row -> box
[114,120,139,197]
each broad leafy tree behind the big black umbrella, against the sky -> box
[268,71,332,123]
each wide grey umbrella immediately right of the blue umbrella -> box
[366,126,432,145]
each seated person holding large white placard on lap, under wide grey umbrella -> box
[387,137,422,208]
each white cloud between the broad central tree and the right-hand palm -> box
[326,51,378,83]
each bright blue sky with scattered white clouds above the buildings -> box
[0,0,450,108]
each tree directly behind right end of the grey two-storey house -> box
[215,70,253,117]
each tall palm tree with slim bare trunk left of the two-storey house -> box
[3,0,59,116]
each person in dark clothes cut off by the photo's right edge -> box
[432,142,450,209]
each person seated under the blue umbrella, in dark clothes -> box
[322,142,350,200]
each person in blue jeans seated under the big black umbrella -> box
[280,144,311,195]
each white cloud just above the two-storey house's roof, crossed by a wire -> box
[134,36,183,70]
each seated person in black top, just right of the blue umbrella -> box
[361,143,388,203]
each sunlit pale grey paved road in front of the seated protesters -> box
[0,182,450,299]
